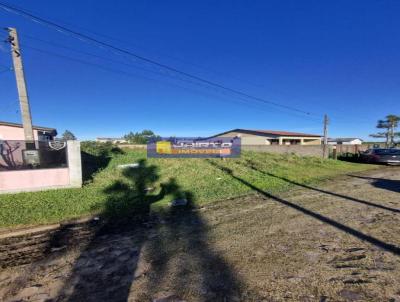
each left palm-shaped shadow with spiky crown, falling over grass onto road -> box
[53,160,165,302]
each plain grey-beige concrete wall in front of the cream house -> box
[242,145,323,157]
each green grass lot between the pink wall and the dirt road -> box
[0,150,373,227]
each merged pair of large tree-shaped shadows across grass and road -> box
[52,160,248,302]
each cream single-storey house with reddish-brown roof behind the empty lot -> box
[212,129,322,145]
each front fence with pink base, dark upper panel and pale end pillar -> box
[0,140,82,193]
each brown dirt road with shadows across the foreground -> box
[0,168,400,302]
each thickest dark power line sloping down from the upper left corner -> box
[0,2,320,116]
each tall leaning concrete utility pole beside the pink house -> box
[7,28,35,150]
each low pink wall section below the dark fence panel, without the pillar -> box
[0,168,70,191]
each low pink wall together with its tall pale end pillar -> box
[0,141,82,193]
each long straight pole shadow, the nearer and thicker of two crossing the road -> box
[208,160,400,256]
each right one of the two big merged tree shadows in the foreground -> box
[140,184,252,301]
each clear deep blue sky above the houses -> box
[0,0,400,139]
